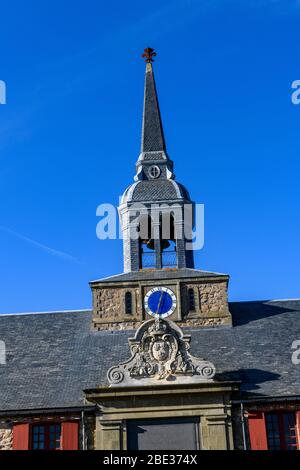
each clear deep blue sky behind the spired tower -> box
[0,0,300,313]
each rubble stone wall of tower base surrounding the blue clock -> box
[93,279,231,331]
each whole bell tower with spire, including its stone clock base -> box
[90,47,231,331]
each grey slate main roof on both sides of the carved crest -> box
[0,300,300,411]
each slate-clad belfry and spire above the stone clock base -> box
[119,47,194,272]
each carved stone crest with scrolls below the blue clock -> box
[107,319,216,386]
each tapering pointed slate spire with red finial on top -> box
[141,47,166,153]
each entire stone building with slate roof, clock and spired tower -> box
[0,48,300,450]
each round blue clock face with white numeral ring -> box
[144,287,176,318]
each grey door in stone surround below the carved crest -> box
[127,418,199,450]
